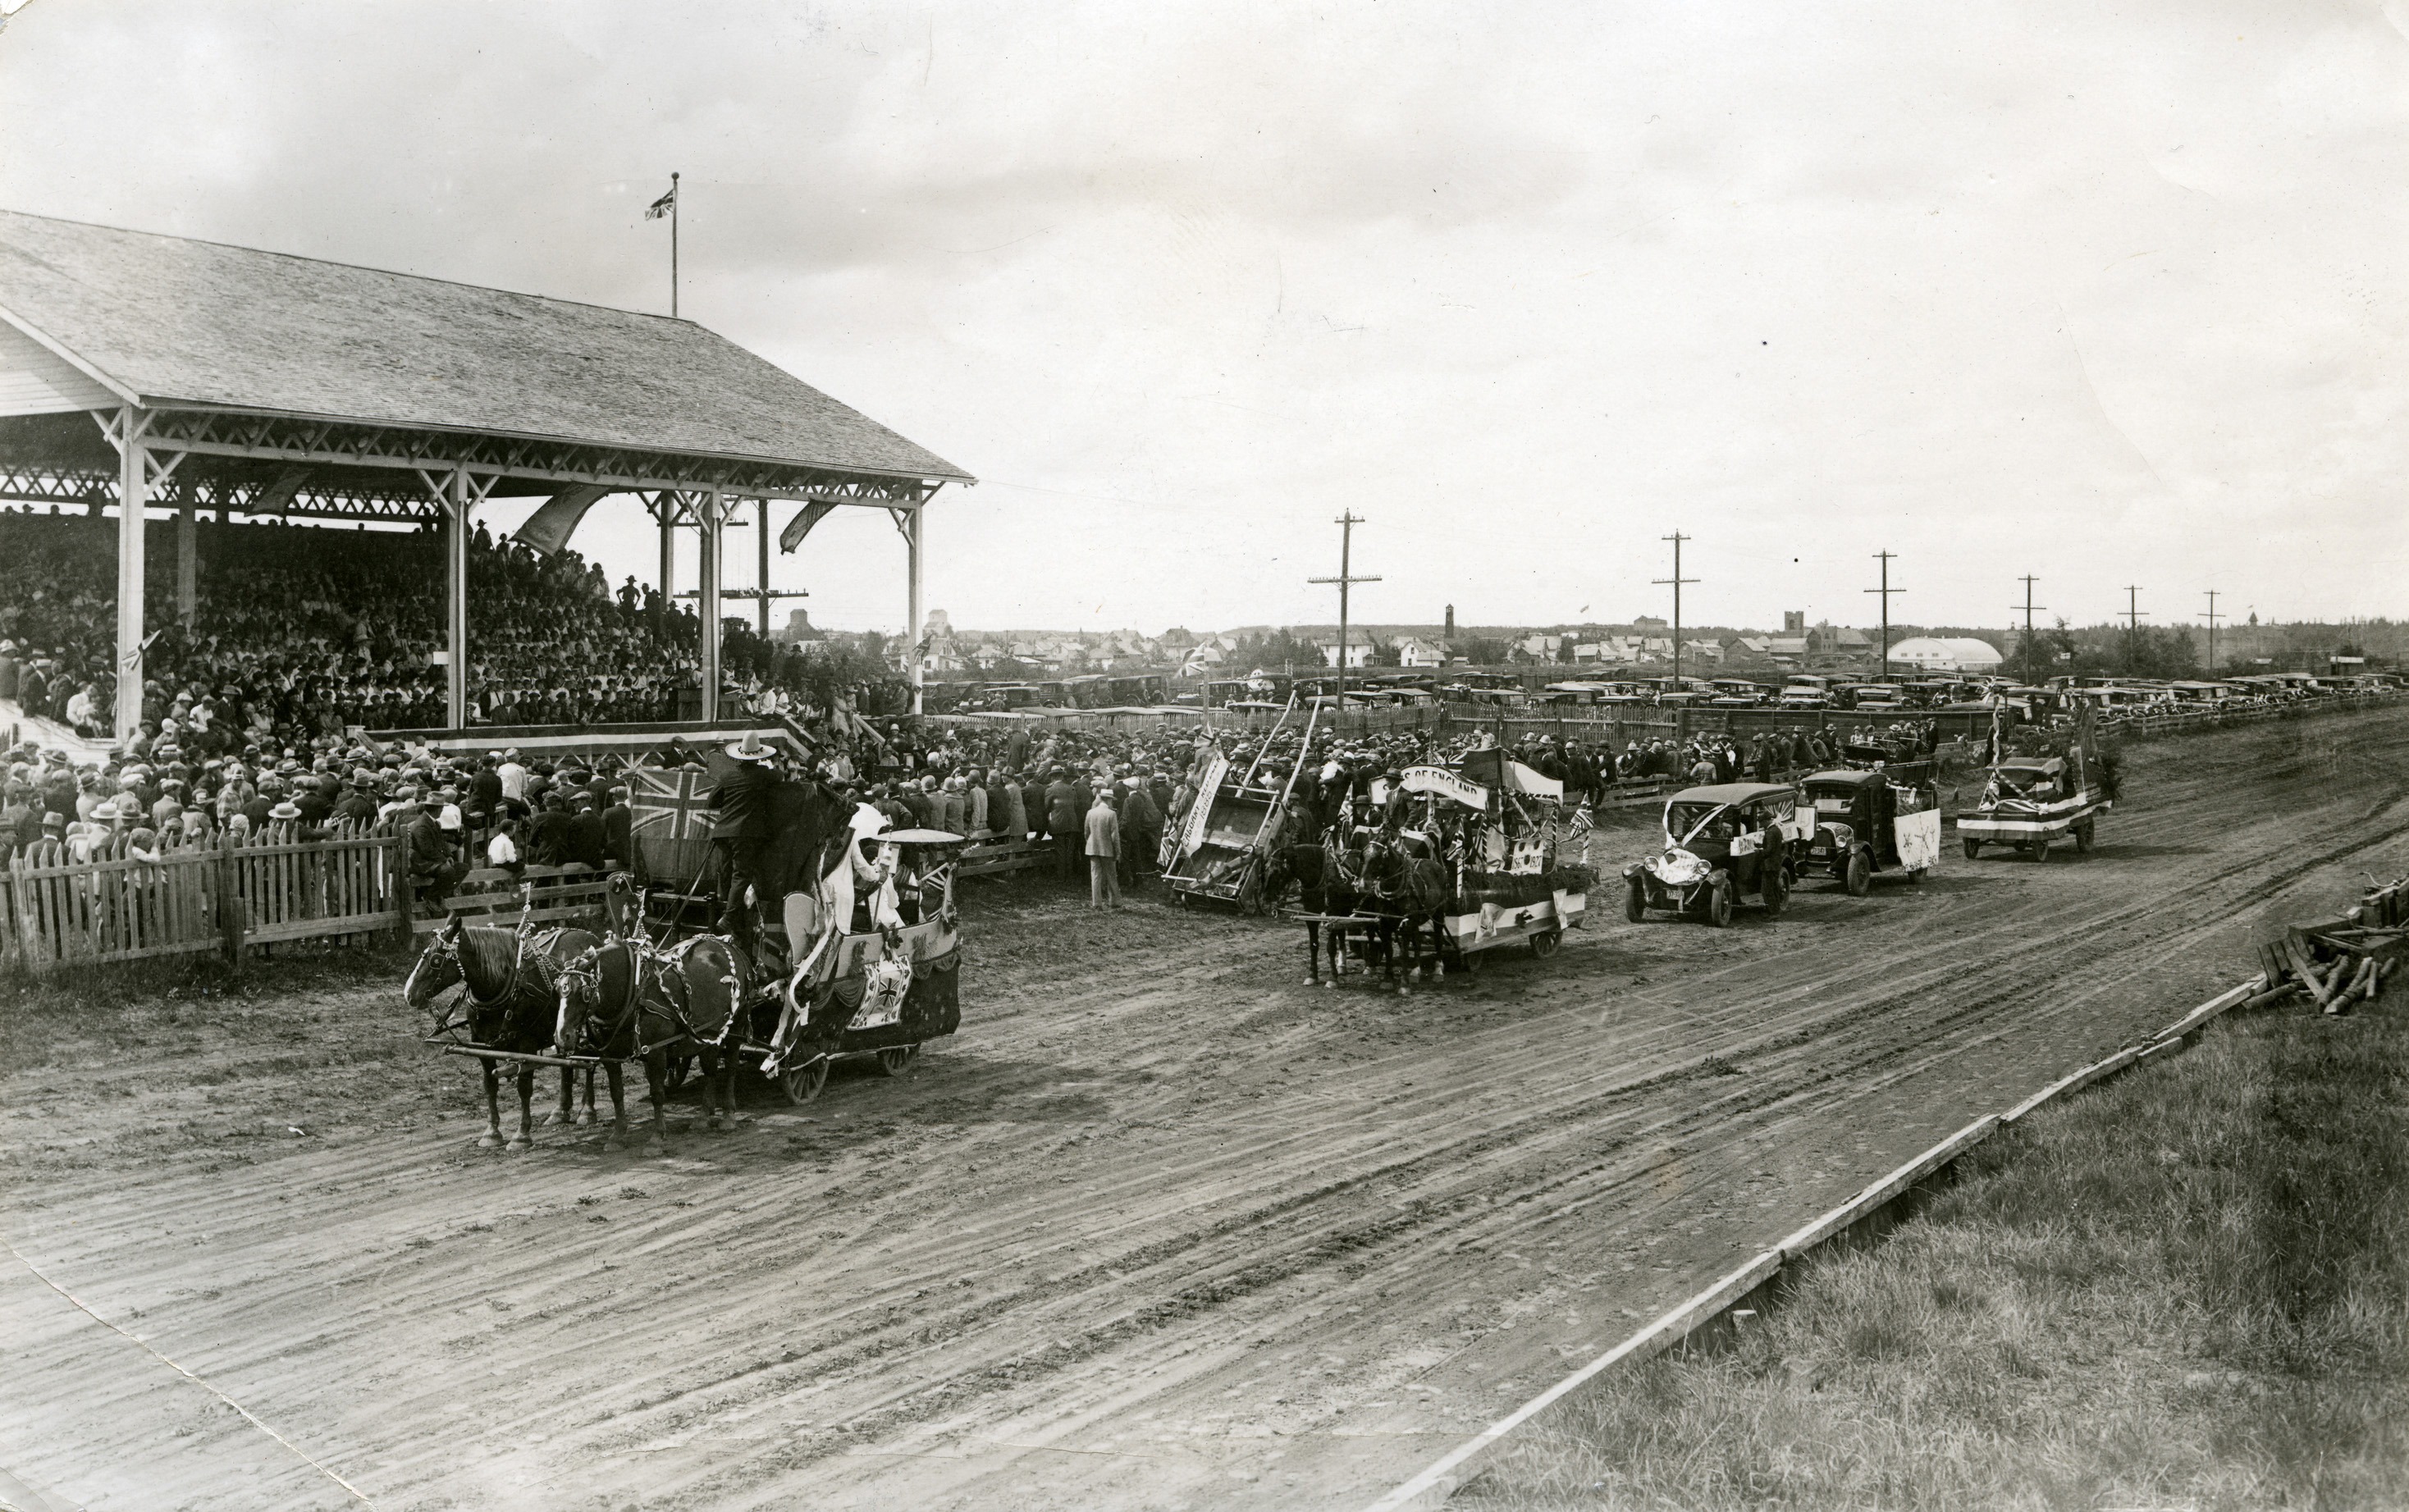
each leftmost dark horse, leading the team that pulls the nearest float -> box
[402,917,597,1151]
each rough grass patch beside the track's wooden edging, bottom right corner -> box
[1450,994,2409,1512]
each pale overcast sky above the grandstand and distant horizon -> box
[0,0,2409,631]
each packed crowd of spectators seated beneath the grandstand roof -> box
[0,508,848,756]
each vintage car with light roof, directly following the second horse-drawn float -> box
[1624,783,1814,927]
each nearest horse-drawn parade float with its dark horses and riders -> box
[405,751,963,1149]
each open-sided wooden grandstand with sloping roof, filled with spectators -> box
[0,212,973,737]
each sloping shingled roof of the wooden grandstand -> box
[0,209,968,482]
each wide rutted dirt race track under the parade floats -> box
[0,708,2409,1512]
